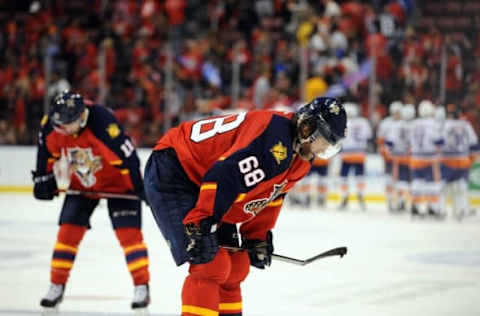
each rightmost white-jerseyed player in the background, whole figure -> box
[441,104,480,219]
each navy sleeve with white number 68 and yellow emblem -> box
[202,115,293,220]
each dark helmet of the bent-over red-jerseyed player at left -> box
[49,90,85,126]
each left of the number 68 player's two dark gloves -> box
[185,218,218,264]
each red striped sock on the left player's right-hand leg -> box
[115,227,150,285]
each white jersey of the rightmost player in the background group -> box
[442,119,478,169]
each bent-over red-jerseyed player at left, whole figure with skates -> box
[32,91,150,310]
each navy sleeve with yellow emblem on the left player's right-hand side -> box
[87,105,143,192]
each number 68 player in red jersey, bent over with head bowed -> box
[145,98,346,316]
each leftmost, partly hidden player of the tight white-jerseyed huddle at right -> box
[377,101,403,211]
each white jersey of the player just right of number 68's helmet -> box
[342,117,372,163]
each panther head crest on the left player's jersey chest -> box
[67,147,102,188]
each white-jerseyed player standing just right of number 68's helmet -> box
[339,103,373,210]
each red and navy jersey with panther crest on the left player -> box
[37,105,143,193]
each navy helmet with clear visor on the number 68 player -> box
[293,97,347,159]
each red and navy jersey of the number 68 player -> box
[154,111,311,239]
